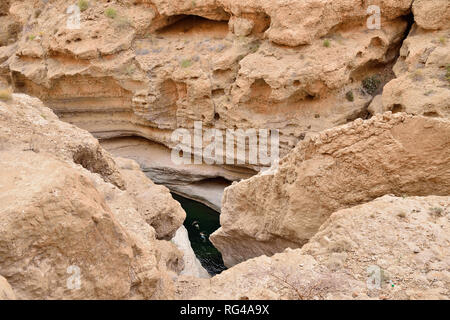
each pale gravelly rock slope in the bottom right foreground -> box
[177,195,450,299]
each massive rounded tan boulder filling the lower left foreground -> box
[0,95,184,299]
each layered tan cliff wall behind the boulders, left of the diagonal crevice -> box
[0,0,412,202]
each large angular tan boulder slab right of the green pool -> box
[210,113,450,266]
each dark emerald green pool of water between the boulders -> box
[172,194,226,275]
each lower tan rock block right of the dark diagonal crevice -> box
[382,26,450,118]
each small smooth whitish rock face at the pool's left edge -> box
[171,226,210,278]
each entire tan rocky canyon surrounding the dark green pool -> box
[0,0,450,299]
